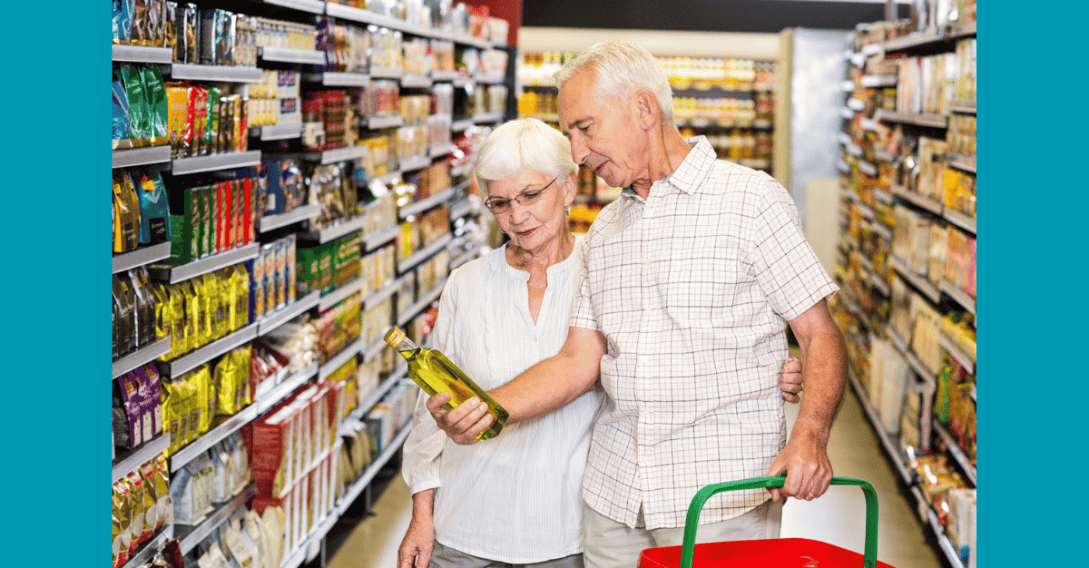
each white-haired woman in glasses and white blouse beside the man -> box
[397,119,800,568]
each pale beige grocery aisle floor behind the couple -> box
[329,386,942,568]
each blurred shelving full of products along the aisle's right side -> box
[835,11,977,566]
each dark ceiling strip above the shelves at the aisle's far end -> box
[522,0,910,33]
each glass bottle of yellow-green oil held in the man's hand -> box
[386,326,510,442]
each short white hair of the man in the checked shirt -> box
[554,41,673,123]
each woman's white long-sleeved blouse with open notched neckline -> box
[402,236,604,564]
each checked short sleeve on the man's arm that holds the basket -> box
[751,174,840,321]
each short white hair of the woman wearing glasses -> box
[474,119,578,193]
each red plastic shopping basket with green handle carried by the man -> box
[639,476,893,568]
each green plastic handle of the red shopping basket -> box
[681,476,878,568]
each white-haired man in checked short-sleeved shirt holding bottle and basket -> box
[428,41,846,567]
